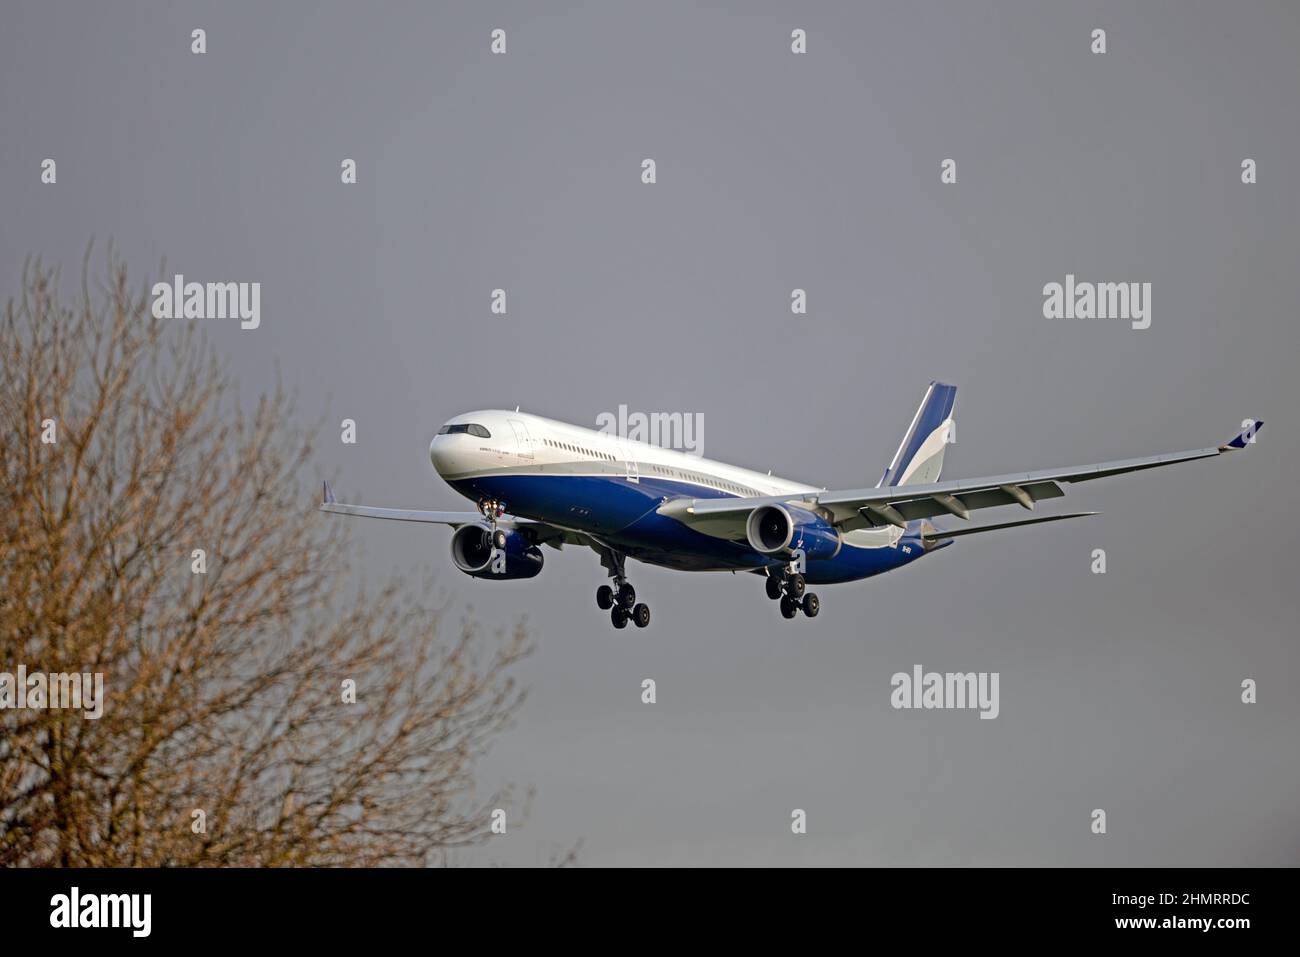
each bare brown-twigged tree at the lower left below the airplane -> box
[0,251,528,866]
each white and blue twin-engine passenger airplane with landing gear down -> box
[320,382,1264,628]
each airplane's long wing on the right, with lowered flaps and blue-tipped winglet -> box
[659,421,1264,538]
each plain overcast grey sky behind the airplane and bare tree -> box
[0,0,1300,866]
